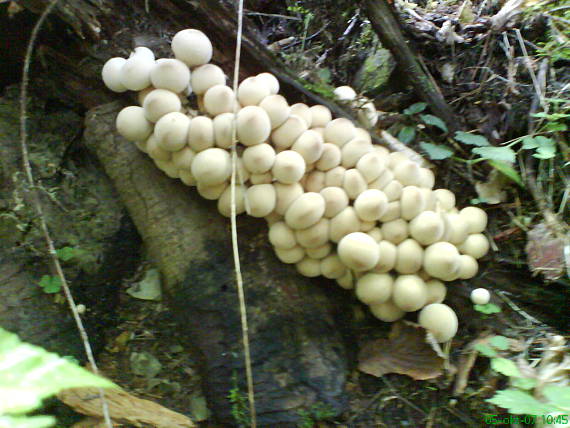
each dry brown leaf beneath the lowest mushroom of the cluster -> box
[358,322,445,380]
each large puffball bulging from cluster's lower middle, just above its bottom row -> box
[337,232,380,272]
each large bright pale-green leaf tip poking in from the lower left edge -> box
[0,328,115,415]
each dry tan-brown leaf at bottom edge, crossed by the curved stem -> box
[58,388,195,428]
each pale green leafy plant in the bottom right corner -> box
[475,336,570,422]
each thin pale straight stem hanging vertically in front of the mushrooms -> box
[230,0,257,428]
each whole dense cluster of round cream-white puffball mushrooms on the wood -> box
[102,29,489,342]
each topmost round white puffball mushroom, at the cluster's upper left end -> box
[171,29,213,67]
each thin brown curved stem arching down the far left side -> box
[20,0,113,428]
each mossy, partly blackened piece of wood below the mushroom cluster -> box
[86,103,346,426]
